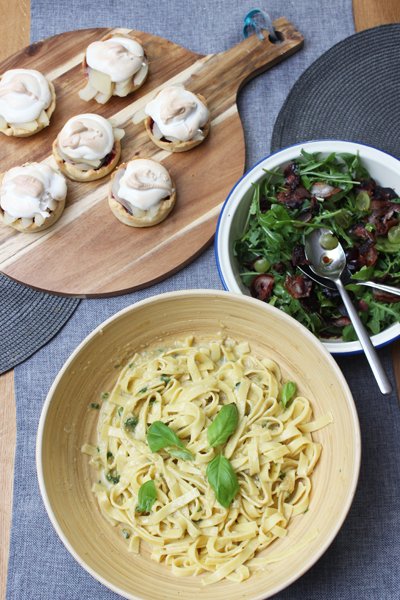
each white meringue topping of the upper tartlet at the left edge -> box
[0,69,51,123]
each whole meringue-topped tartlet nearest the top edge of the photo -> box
[79,33,149,104]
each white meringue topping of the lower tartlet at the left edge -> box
[0,163,67,219]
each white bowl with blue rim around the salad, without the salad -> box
[215,140,400,354]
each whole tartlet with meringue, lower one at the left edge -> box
[0,163,67,233]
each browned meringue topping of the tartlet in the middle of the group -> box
[58,113,114,161]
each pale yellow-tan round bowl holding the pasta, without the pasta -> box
[37,290,360,600]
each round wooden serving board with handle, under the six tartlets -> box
[0,18,303,297]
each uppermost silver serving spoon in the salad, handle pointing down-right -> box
[304,228,392,394]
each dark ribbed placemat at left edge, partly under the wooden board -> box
[0,274,80,374]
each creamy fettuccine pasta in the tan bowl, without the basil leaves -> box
[82,338,332,584]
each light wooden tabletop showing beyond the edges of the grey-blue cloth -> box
[0,0,400,599]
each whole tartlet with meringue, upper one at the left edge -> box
[0,69,56,137]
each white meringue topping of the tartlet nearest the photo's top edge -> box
[86,36,144,83]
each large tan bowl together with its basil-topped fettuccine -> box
[37,291,360,600]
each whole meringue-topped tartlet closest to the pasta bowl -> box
[108,158,176,227]
